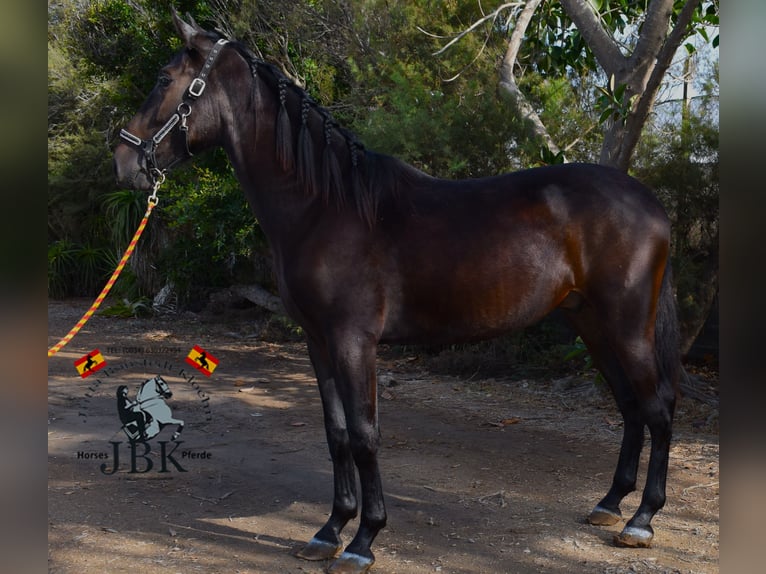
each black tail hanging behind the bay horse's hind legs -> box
[654,259,681,394]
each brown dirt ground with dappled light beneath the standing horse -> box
[48,300,719,574]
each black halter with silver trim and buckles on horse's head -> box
[120,39,229,187]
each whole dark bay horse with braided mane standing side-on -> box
[115,11,680,572]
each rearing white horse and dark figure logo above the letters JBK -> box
[117,375,184,442]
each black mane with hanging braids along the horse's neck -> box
[219,37,428,227]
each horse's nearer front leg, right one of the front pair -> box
[327,331,386,574]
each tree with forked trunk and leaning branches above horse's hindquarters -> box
[436,0,718,171]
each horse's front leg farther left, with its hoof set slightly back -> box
[297,339,357,560]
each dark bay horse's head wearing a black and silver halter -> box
[114,9,234,190]
